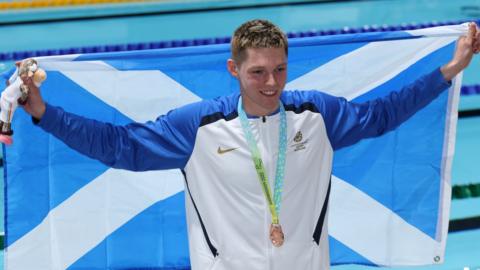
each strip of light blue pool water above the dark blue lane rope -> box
[0,0,477,51]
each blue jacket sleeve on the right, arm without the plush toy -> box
[316,69,450,150]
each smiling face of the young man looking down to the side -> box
[227,48,287,116]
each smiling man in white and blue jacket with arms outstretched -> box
[18,20,480,270]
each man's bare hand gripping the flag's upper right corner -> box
[440,22,480,81]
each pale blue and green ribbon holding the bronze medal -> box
[237,97,287,224]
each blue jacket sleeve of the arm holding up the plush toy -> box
[38,100,201,171]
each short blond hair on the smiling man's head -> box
[231,19,288,63]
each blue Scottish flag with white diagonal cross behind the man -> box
[0,26,467,270]
